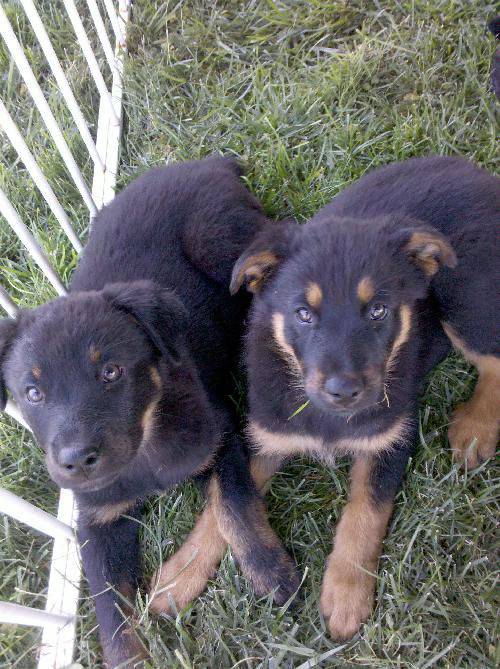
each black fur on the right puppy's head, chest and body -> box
[232,157,500,632]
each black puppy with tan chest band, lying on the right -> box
[162,157,500,639]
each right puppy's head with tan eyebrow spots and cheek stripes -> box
[232,217,456,416]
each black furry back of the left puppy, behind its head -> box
[71,157,265,292]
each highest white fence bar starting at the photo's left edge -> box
[0,4,97,216]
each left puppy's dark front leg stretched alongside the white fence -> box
[78,513,147,669]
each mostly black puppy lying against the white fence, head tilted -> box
[0,158,295,666]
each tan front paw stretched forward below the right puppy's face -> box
[320,568,375,641]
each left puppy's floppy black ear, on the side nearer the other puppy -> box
[102,281,188,364]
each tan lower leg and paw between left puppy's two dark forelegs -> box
[150,479,227,614]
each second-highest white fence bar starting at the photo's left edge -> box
[0,100,82,253]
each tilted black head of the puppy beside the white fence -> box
[0,281,185,491]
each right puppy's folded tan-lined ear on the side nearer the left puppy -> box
[229,220,299,295]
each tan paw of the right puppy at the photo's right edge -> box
[448,401,499,469]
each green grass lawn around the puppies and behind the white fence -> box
[0,0,500,669]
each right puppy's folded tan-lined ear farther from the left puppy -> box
[401,226,457,277]
